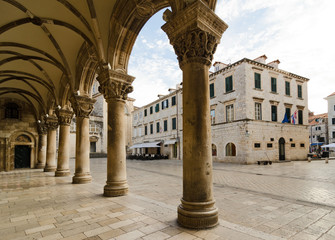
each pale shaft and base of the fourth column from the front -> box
[55,124,70,177]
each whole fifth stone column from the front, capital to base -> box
[44,116,58,172]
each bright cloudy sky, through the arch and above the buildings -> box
[128,0,335,113]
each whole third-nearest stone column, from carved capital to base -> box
[71,96,96,183]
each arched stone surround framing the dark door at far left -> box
[7,131,37,170]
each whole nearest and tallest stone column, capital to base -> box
[162,1,227,229]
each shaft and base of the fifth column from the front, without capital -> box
[44,128,56,172]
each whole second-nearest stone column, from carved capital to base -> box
[98,69,135,197]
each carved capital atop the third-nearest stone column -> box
[70,96,97,118]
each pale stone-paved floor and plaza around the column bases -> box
[0,159,335,240]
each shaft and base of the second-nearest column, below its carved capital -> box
[104,98,128,197]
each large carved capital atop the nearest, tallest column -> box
[162,1,228,68]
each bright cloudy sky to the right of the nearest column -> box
[214,0,335,113]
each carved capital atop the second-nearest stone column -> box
[97,69,135,102]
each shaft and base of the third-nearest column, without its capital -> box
[72,117,92,183]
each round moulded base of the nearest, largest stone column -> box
[178,199,219,229]
